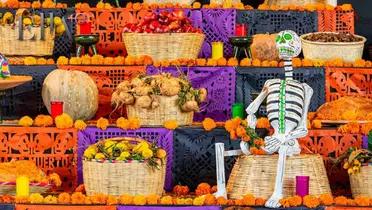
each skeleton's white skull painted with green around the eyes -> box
[276,30,301,59]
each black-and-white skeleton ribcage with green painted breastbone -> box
[267,79,304,133]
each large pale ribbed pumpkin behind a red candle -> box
[42,69,98,120]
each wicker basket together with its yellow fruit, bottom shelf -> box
[83,137,166,196]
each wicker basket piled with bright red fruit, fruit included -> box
[123,9,205,61]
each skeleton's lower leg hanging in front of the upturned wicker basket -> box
[265,144,288,208]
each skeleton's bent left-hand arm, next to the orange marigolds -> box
[245,80,271,129]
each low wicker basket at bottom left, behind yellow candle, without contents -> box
[0,182,55,196]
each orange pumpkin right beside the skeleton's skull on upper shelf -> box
[251,34,279,61]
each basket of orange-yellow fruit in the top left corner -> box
[0,9,65,56]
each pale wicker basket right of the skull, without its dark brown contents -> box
[301,32,367,62]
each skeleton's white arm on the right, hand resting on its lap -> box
[288,83,313,139]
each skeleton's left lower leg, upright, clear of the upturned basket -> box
[214,143,227,198]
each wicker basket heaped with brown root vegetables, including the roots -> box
[111,73,207,126]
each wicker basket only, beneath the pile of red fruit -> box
[123,33,205,61]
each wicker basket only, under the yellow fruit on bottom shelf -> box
[83,137,166,196]
